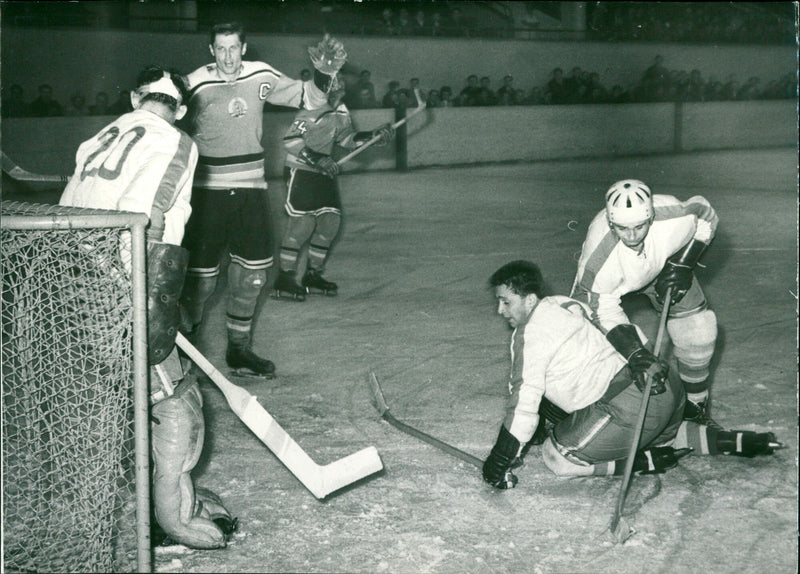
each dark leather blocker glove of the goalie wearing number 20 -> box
[147,243,189,365]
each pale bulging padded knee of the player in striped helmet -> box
[667,309,717,383]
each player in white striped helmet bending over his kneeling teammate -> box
[572,179,718,425]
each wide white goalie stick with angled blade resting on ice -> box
[177,333,383,499]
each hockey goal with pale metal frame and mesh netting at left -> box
[0,201,152,572]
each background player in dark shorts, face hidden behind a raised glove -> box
[275,76,394,301]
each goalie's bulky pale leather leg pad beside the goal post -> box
[151,381,226,548]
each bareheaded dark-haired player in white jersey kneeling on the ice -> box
[483,261,782,489]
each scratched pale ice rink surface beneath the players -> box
[139,149,798,574]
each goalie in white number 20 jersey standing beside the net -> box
[59,67,237,548]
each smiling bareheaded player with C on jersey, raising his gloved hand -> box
[182,23,346,378]
